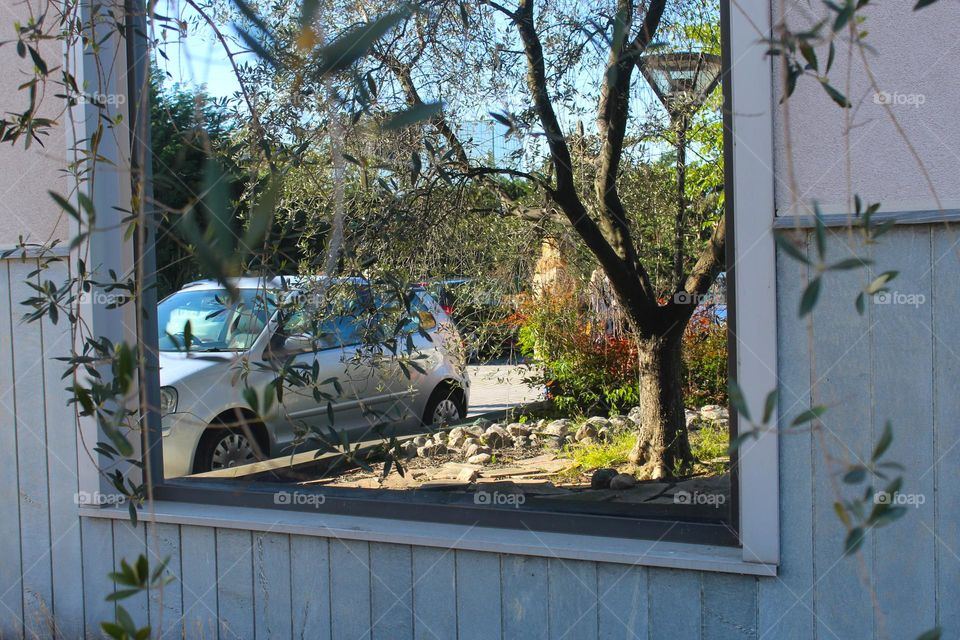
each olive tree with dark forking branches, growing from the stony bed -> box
[344,0,725,478]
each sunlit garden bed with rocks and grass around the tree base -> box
[299,406,730,506]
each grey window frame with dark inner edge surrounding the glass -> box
[77,0,780,574]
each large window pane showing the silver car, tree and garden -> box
[124,0,752,545]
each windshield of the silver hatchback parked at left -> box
[157,289,274,352]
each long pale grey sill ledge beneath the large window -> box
[80,502,777,576]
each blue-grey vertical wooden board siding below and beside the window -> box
[0,226,960,640]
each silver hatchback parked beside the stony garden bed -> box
[158,278,470,477]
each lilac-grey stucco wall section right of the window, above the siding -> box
[772,0,960,213]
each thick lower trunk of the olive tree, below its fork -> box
[630,332,693,480]
